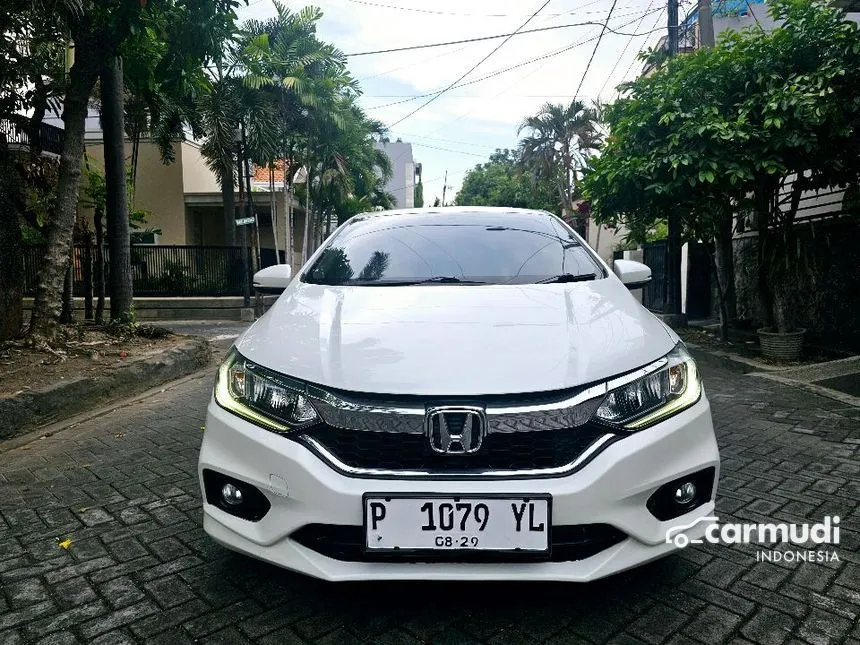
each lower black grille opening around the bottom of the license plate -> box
[290,524,627,562]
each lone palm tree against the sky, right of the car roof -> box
[517,100,603,236]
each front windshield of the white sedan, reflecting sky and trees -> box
[303,214,603,286]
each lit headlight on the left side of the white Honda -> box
[215,349,319,432]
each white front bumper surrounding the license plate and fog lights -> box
[198,394,719,581]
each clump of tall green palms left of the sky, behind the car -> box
[201,3,393,261]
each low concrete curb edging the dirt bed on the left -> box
[0,338,212,440]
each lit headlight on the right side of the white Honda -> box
[594,344,702,430]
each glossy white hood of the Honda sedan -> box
[237,278,676,396]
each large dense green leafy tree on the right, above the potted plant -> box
[584,0,860,332]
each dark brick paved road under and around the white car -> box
[0,352,860,645]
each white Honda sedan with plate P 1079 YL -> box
[199,207,719,581]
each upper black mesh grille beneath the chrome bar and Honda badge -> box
[306,424,607,473]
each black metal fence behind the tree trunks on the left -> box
[24,245,250,297]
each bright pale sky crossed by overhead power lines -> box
[238,0,694,204]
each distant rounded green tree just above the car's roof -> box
[455,149,559,213]
